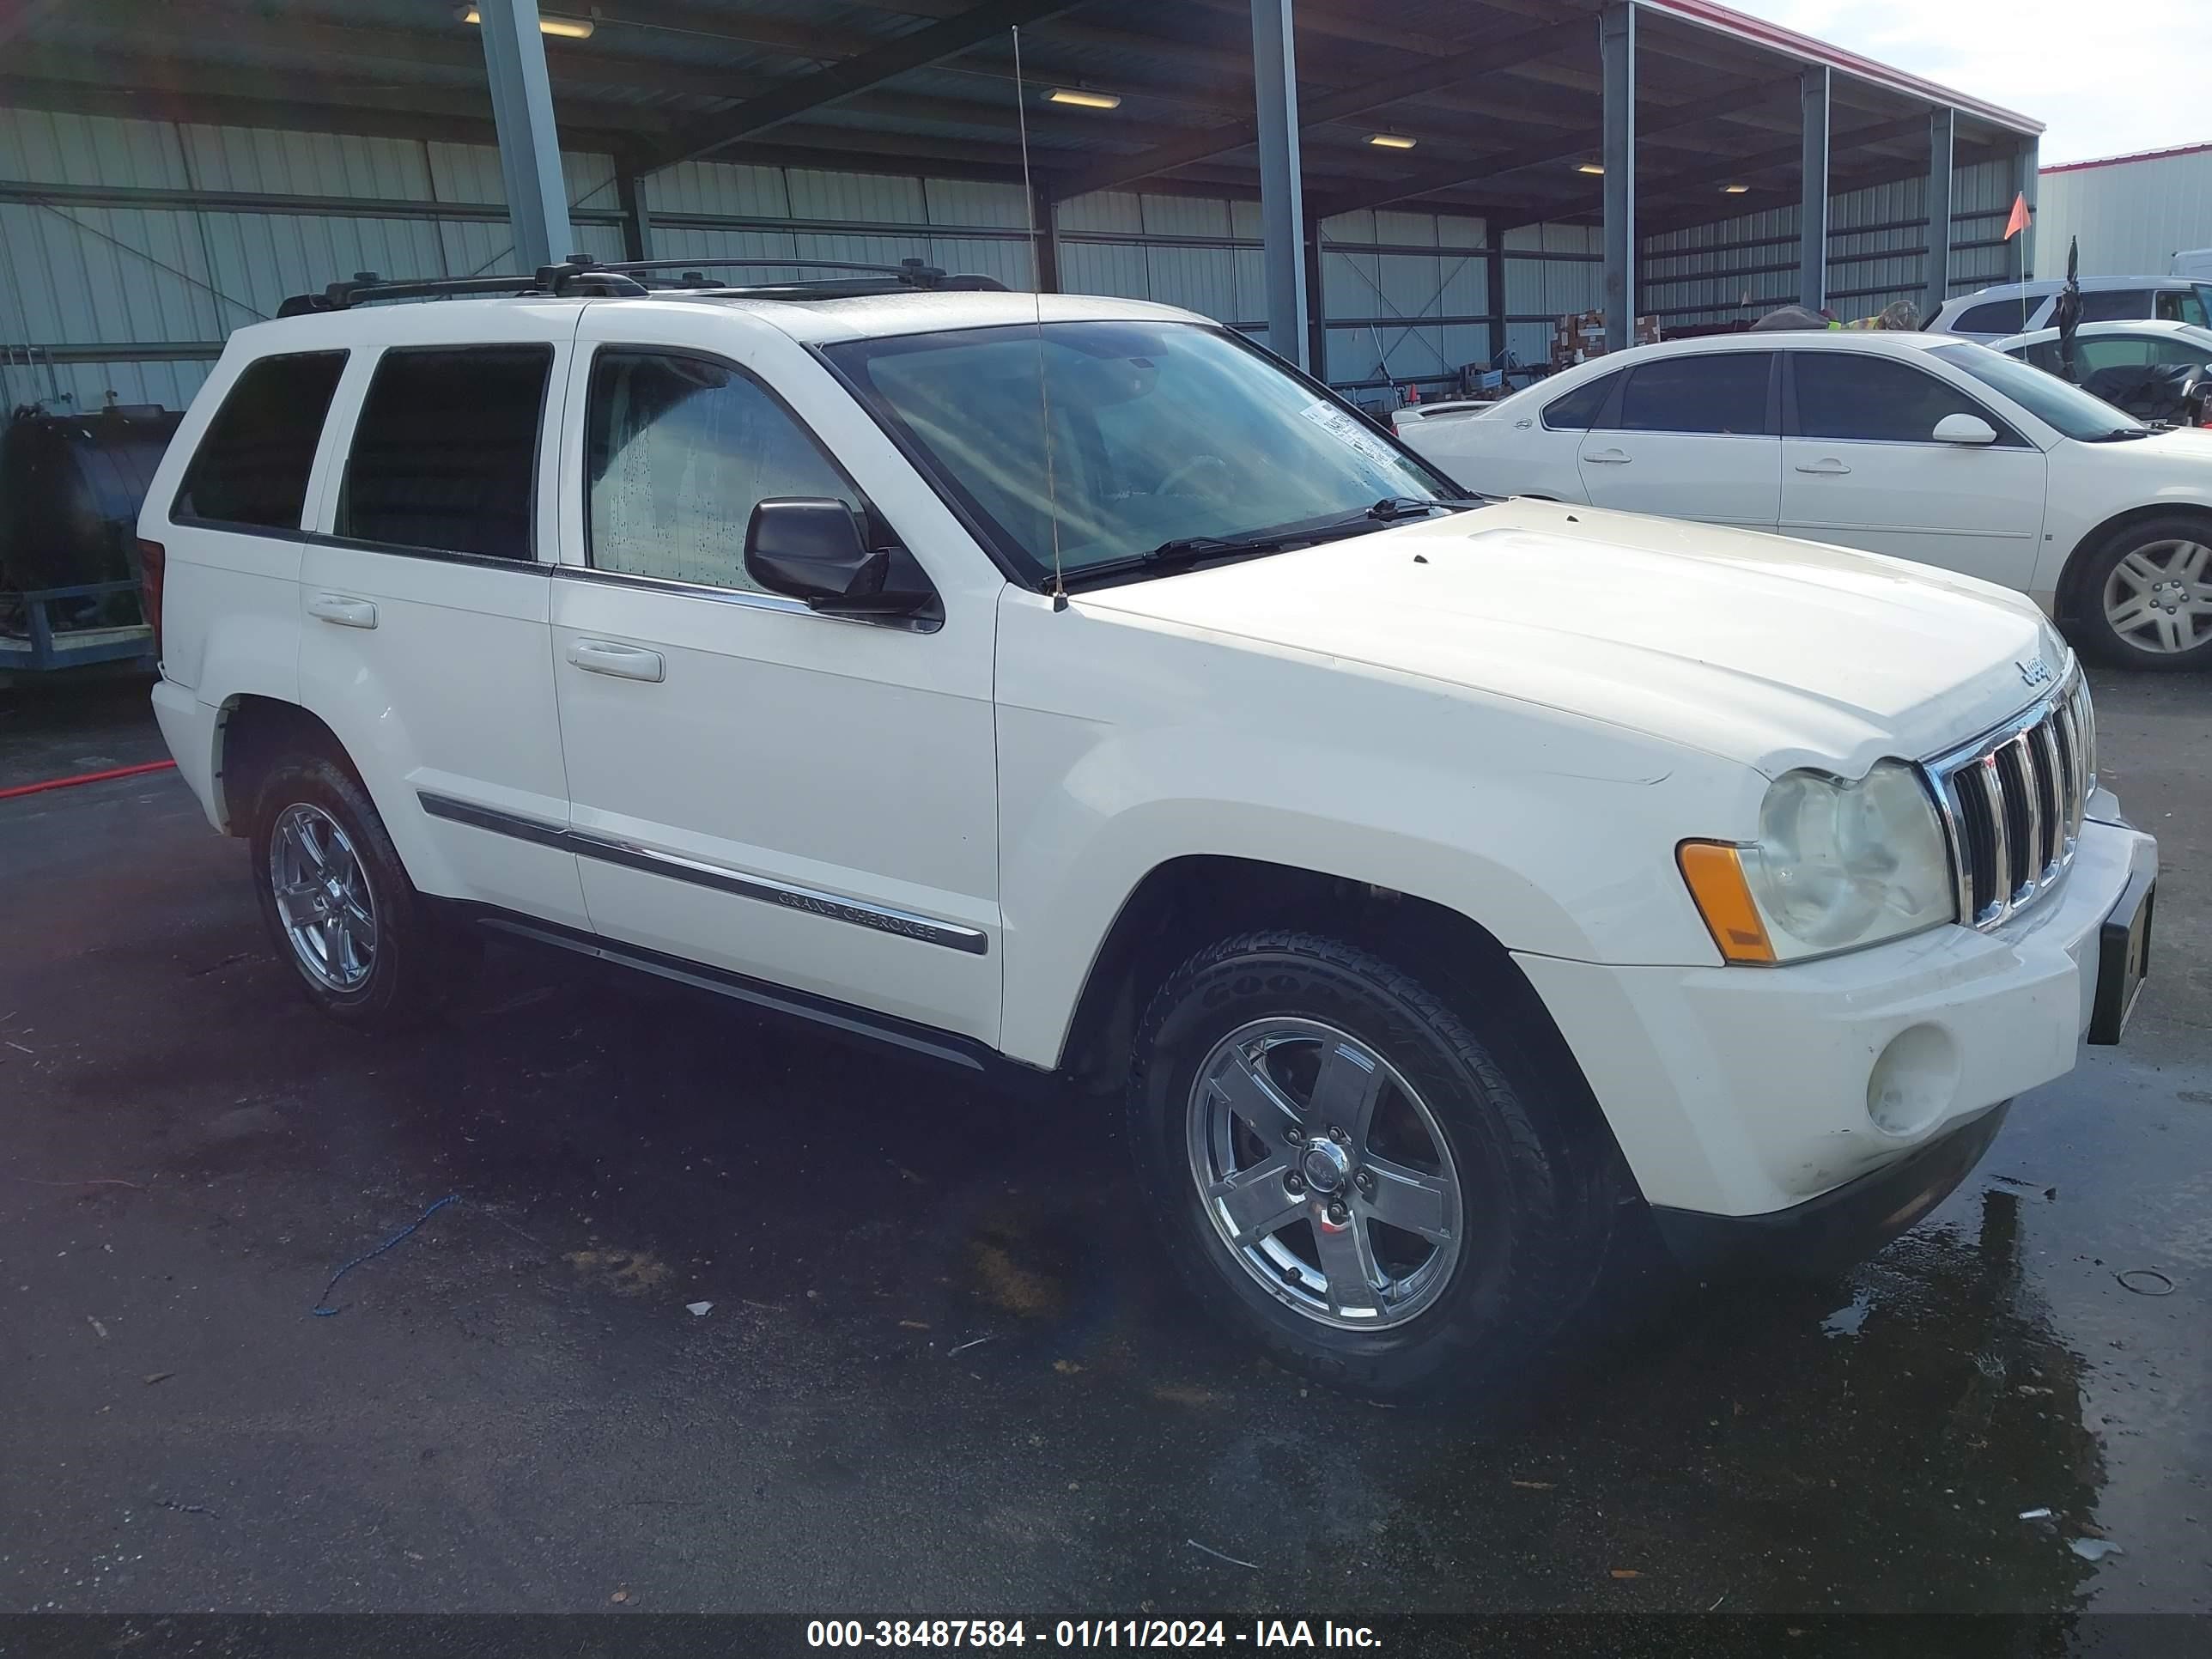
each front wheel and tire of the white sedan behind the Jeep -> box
[2075,514,2212,672]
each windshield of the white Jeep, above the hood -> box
[825,321,1464,581]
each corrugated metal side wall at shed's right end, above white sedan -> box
[1644,161,2051,327]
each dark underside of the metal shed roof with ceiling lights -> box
[0,0,2042,232]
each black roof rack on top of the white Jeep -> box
[276,254,1006,316]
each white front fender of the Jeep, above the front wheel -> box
[998,595,1765,1066]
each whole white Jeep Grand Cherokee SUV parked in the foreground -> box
[142,268,2157,1398]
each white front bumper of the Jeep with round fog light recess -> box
[1517,813,2157,1217]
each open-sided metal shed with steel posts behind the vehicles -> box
[0,0,2039,410]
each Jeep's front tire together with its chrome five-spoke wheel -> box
[1128,933,1610,1401]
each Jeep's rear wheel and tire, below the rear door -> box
[250,754,458,1030]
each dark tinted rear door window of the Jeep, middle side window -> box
[337,345,553,560]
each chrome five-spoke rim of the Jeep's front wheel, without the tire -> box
[1186,1020,1462,1332]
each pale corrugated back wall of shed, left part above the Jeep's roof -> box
[0,108,1033,410]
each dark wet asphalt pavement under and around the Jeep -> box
[0,677,2212,1631]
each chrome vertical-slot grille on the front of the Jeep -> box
[1927,668,2097,929]
